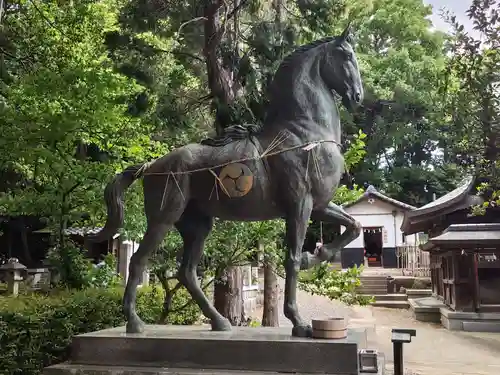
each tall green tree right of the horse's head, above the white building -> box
[348,0,458,206]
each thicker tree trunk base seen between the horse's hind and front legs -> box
[214,266,244,326]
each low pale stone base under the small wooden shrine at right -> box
[440,307,500,332]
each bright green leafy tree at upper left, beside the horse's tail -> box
[0,0,170,236]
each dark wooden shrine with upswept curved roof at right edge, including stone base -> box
[401,178,500,332]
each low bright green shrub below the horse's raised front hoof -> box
[299,263,372,306]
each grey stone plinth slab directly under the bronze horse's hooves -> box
[70,326,367,375]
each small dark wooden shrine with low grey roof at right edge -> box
[422,224,500,312]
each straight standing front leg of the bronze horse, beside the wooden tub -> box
[283,197,313,337]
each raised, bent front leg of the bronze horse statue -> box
[300,202,361,269]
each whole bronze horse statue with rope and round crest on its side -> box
[93,26,363,337]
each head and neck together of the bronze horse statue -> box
[264,25,364,129]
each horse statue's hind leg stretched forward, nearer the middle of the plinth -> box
[175,207,231,331]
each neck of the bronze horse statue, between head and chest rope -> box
[262,52,341,142]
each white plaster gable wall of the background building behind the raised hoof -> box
[342,199,416,248]
